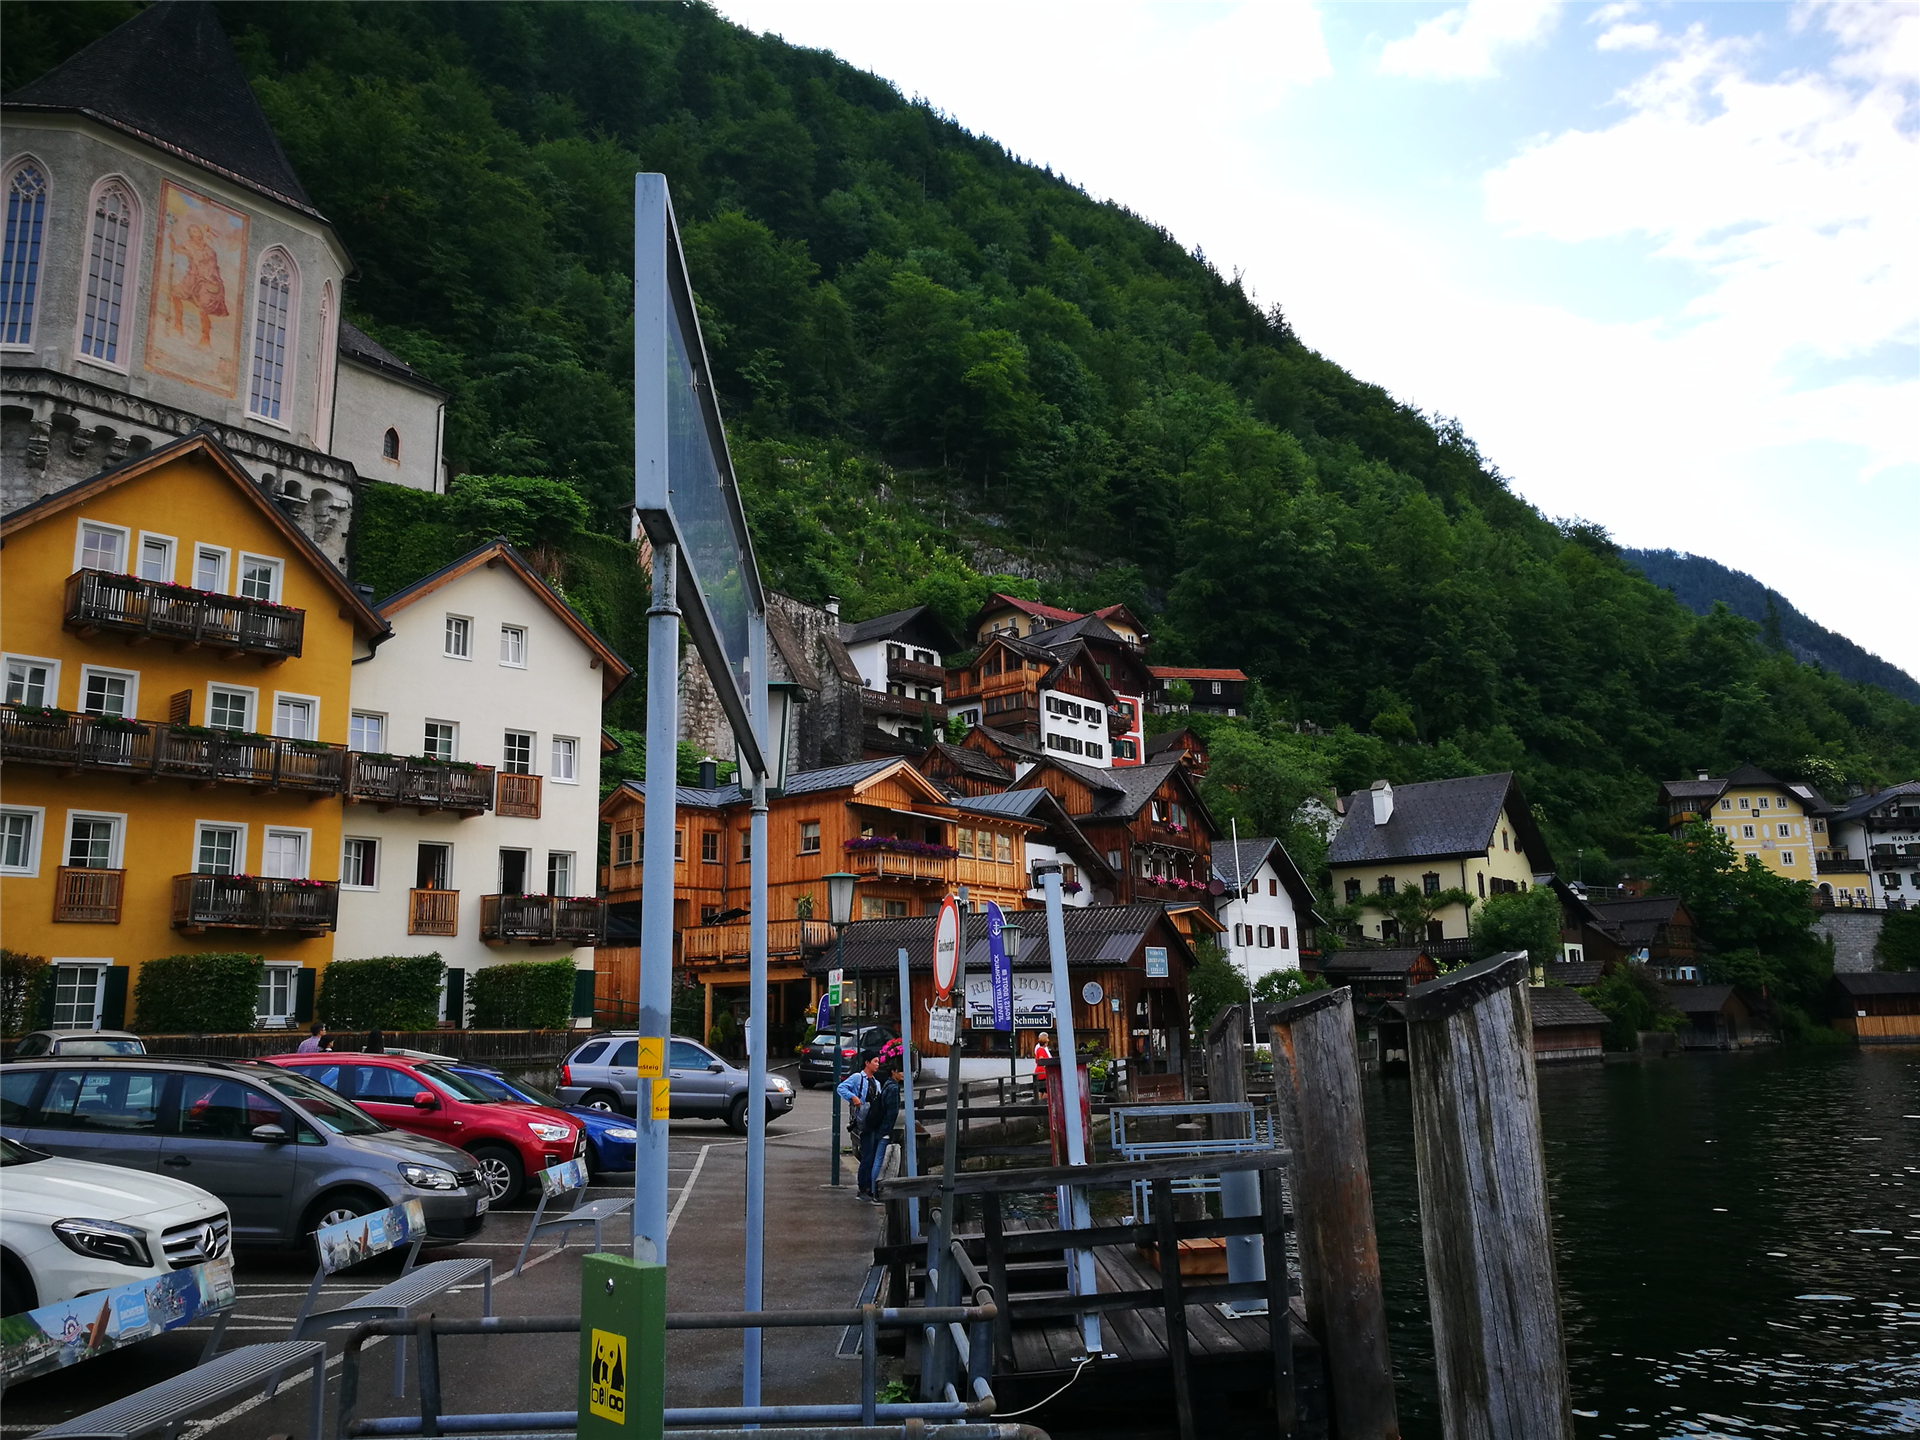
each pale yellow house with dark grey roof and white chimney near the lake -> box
[1327,772,1553,954]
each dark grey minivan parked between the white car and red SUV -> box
[0,1056,490,1246]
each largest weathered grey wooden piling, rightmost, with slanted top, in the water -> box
[1405,950,1572,1440]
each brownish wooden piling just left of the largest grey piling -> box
[1271,985,1400,1440]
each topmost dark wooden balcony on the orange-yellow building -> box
[65,570,307,664]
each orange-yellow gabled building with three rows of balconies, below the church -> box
[0,432,388,1029]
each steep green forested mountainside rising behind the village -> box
[4,4,1920,879]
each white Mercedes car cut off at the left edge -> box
[0,1137,232,1315]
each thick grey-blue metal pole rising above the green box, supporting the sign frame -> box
[634,545,680,1265]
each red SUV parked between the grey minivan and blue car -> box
[269,1052,588,1204]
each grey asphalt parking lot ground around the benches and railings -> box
[0,1071,879,1438]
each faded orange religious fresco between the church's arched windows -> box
[146,180,248,399]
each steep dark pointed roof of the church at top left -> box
[6,0,324,221]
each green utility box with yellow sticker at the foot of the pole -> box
[580,1254,666,1440]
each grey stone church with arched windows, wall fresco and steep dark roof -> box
[0,4,445,568]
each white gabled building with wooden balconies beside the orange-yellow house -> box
[334,541,632,1023]
